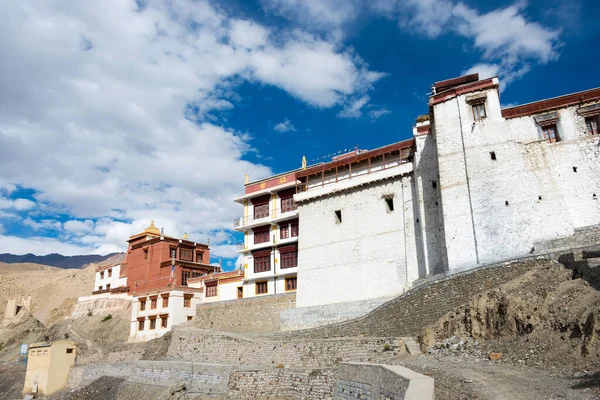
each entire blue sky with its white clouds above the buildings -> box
[0,0,600,267]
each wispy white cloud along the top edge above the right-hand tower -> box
[263,0,561,84]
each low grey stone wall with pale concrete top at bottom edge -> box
[333,363,434,400]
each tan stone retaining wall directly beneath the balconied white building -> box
[196,293,296,332]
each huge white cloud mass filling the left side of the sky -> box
[0,0,384,255]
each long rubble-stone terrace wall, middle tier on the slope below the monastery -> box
[167,329,406,368]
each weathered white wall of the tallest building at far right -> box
[434,85,600,269]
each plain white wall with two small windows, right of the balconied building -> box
[297,173,418,307]
